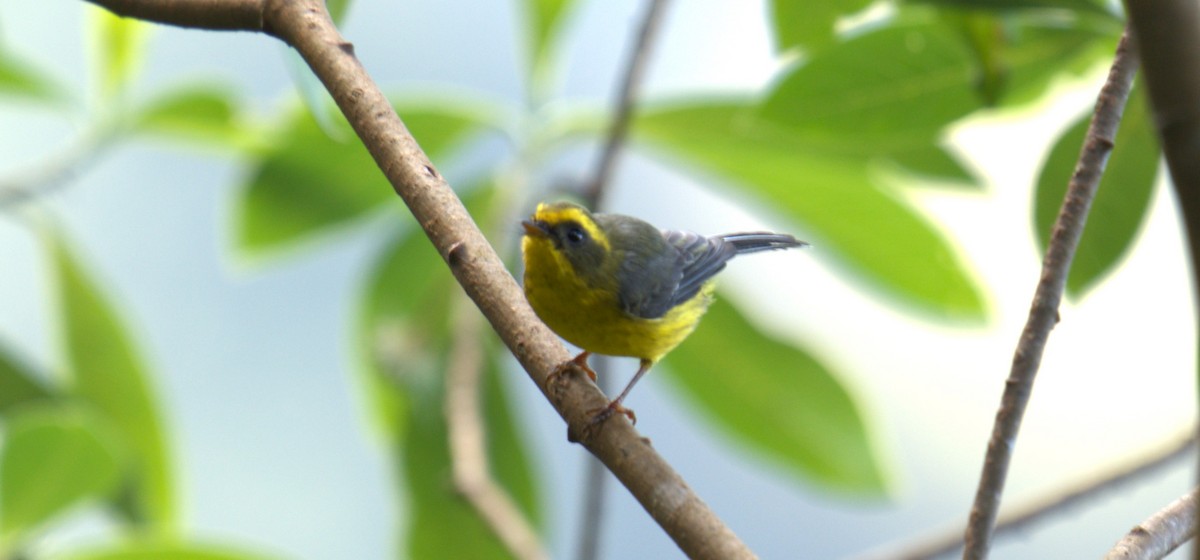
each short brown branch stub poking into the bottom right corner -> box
[1104,489,1200,560]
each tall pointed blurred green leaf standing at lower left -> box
[50,239,175,528]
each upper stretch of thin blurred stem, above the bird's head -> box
[583,0,667,209]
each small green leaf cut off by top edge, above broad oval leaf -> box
[770,0,871,50]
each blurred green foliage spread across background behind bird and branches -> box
[0,0,1158,559]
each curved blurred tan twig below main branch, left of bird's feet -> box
[444,297,547,560]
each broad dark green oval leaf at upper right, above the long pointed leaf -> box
[761,23,982,152]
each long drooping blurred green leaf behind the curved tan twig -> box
[358,188,540,558]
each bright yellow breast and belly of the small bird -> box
[521,235,713,361]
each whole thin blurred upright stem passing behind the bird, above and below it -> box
[575,0,667,560]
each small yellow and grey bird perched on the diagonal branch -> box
[521,203,809,424]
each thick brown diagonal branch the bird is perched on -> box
[90,0,754,559]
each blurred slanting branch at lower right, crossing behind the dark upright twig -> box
[858,434,1196,560]
